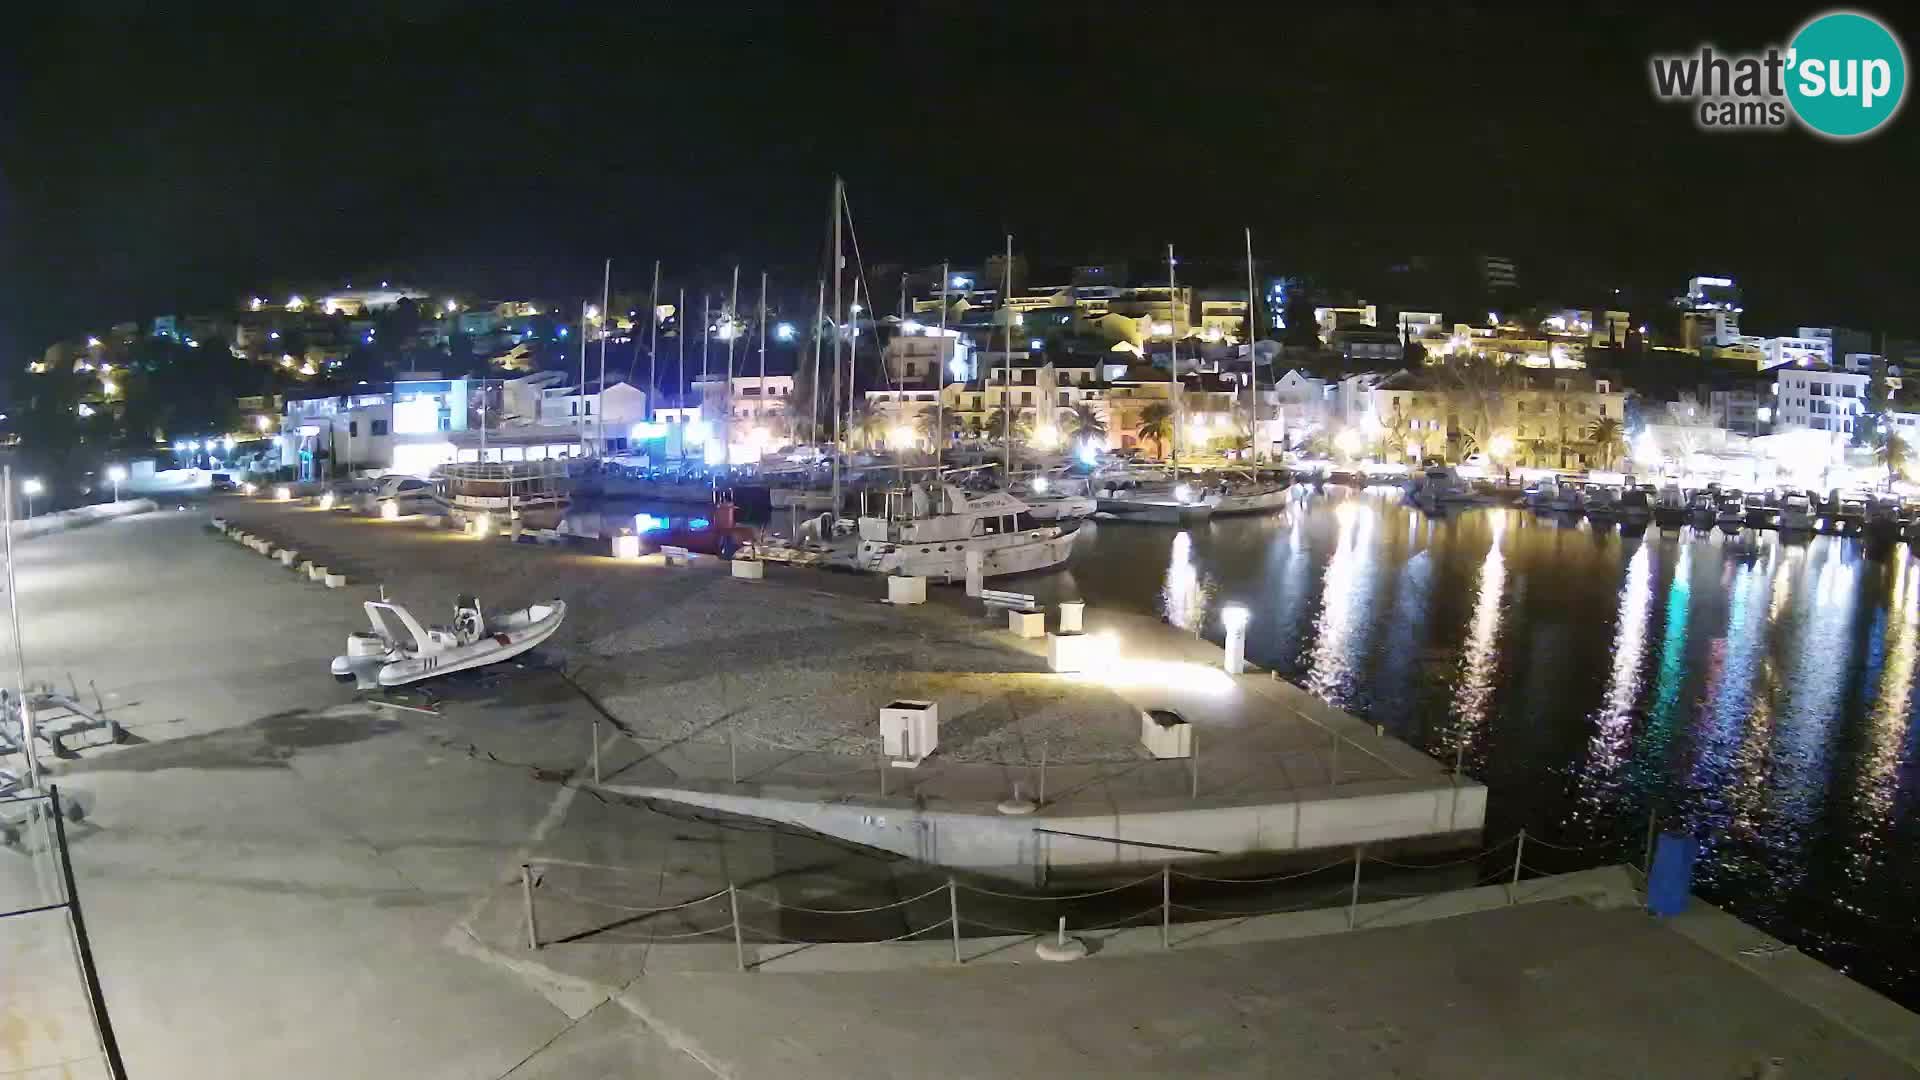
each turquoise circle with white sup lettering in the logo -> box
[1788,12,1907,138]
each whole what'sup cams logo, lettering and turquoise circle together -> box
[1649,12,1907,138]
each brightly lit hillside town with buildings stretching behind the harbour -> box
[15,256,1920,490]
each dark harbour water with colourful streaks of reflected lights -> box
[1027,494,1920,1003]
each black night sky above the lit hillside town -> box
[0,0,1920,363]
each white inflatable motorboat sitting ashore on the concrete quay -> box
[332,596,566,690]
